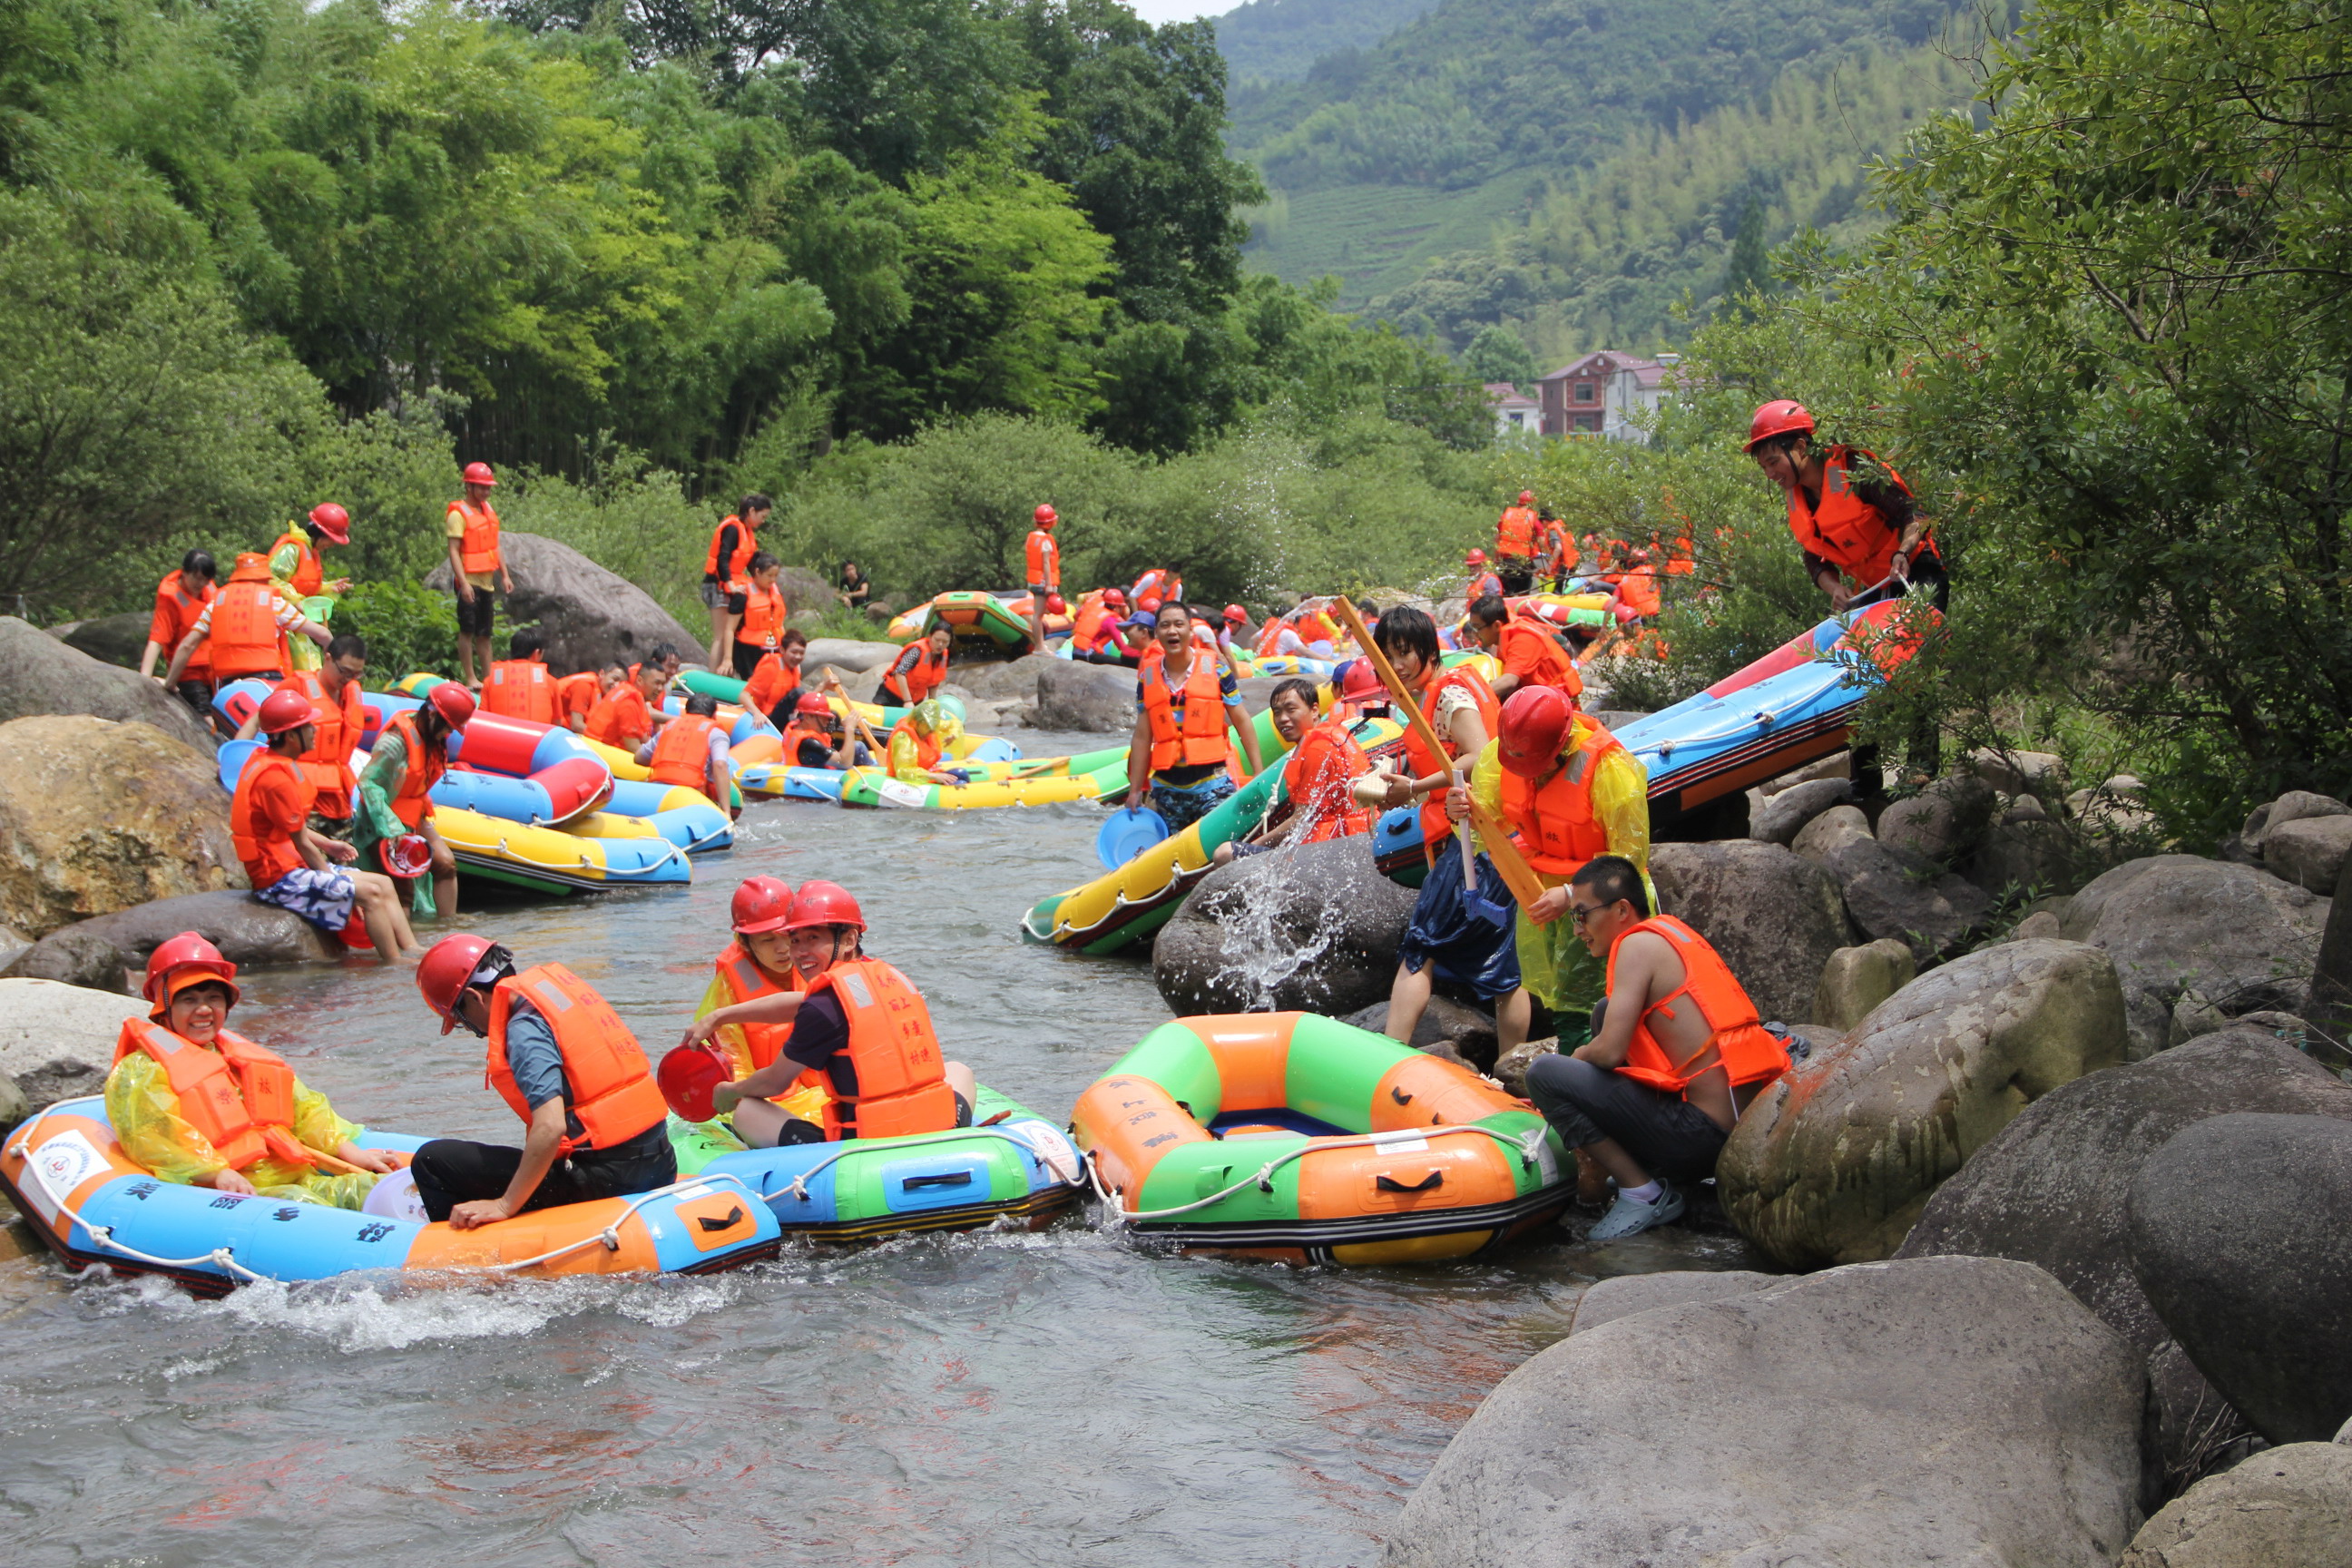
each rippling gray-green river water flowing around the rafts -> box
[0,733,1749,1568]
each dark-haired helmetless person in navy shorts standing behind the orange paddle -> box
[1352,606,1529,1051]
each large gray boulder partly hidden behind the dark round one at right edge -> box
[1896,1030,2352,1485]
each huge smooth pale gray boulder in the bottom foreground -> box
[1383,1258,2142,1568]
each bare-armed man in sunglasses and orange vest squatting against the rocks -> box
[1526,856,1790,1241]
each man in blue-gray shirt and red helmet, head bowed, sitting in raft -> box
[409,934,677,1230]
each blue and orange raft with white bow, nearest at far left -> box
[0,1095,783,1295]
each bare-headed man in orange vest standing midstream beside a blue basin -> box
[1127,604,1265,832]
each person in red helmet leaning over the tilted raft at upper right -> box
[1748,397,1950,613]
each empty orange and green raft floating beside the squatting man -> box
[1070,1014,1576,1265]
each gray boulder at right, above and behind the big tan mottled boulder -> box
[2063,856,2328,1060]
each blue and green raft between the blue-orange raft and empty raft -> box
[671,1083,1087,1241]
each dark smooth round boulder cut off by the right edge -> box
[2129,1112,2352,1444]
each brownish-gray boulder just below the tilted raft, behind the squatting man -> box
[1649,841,1853,1023]
